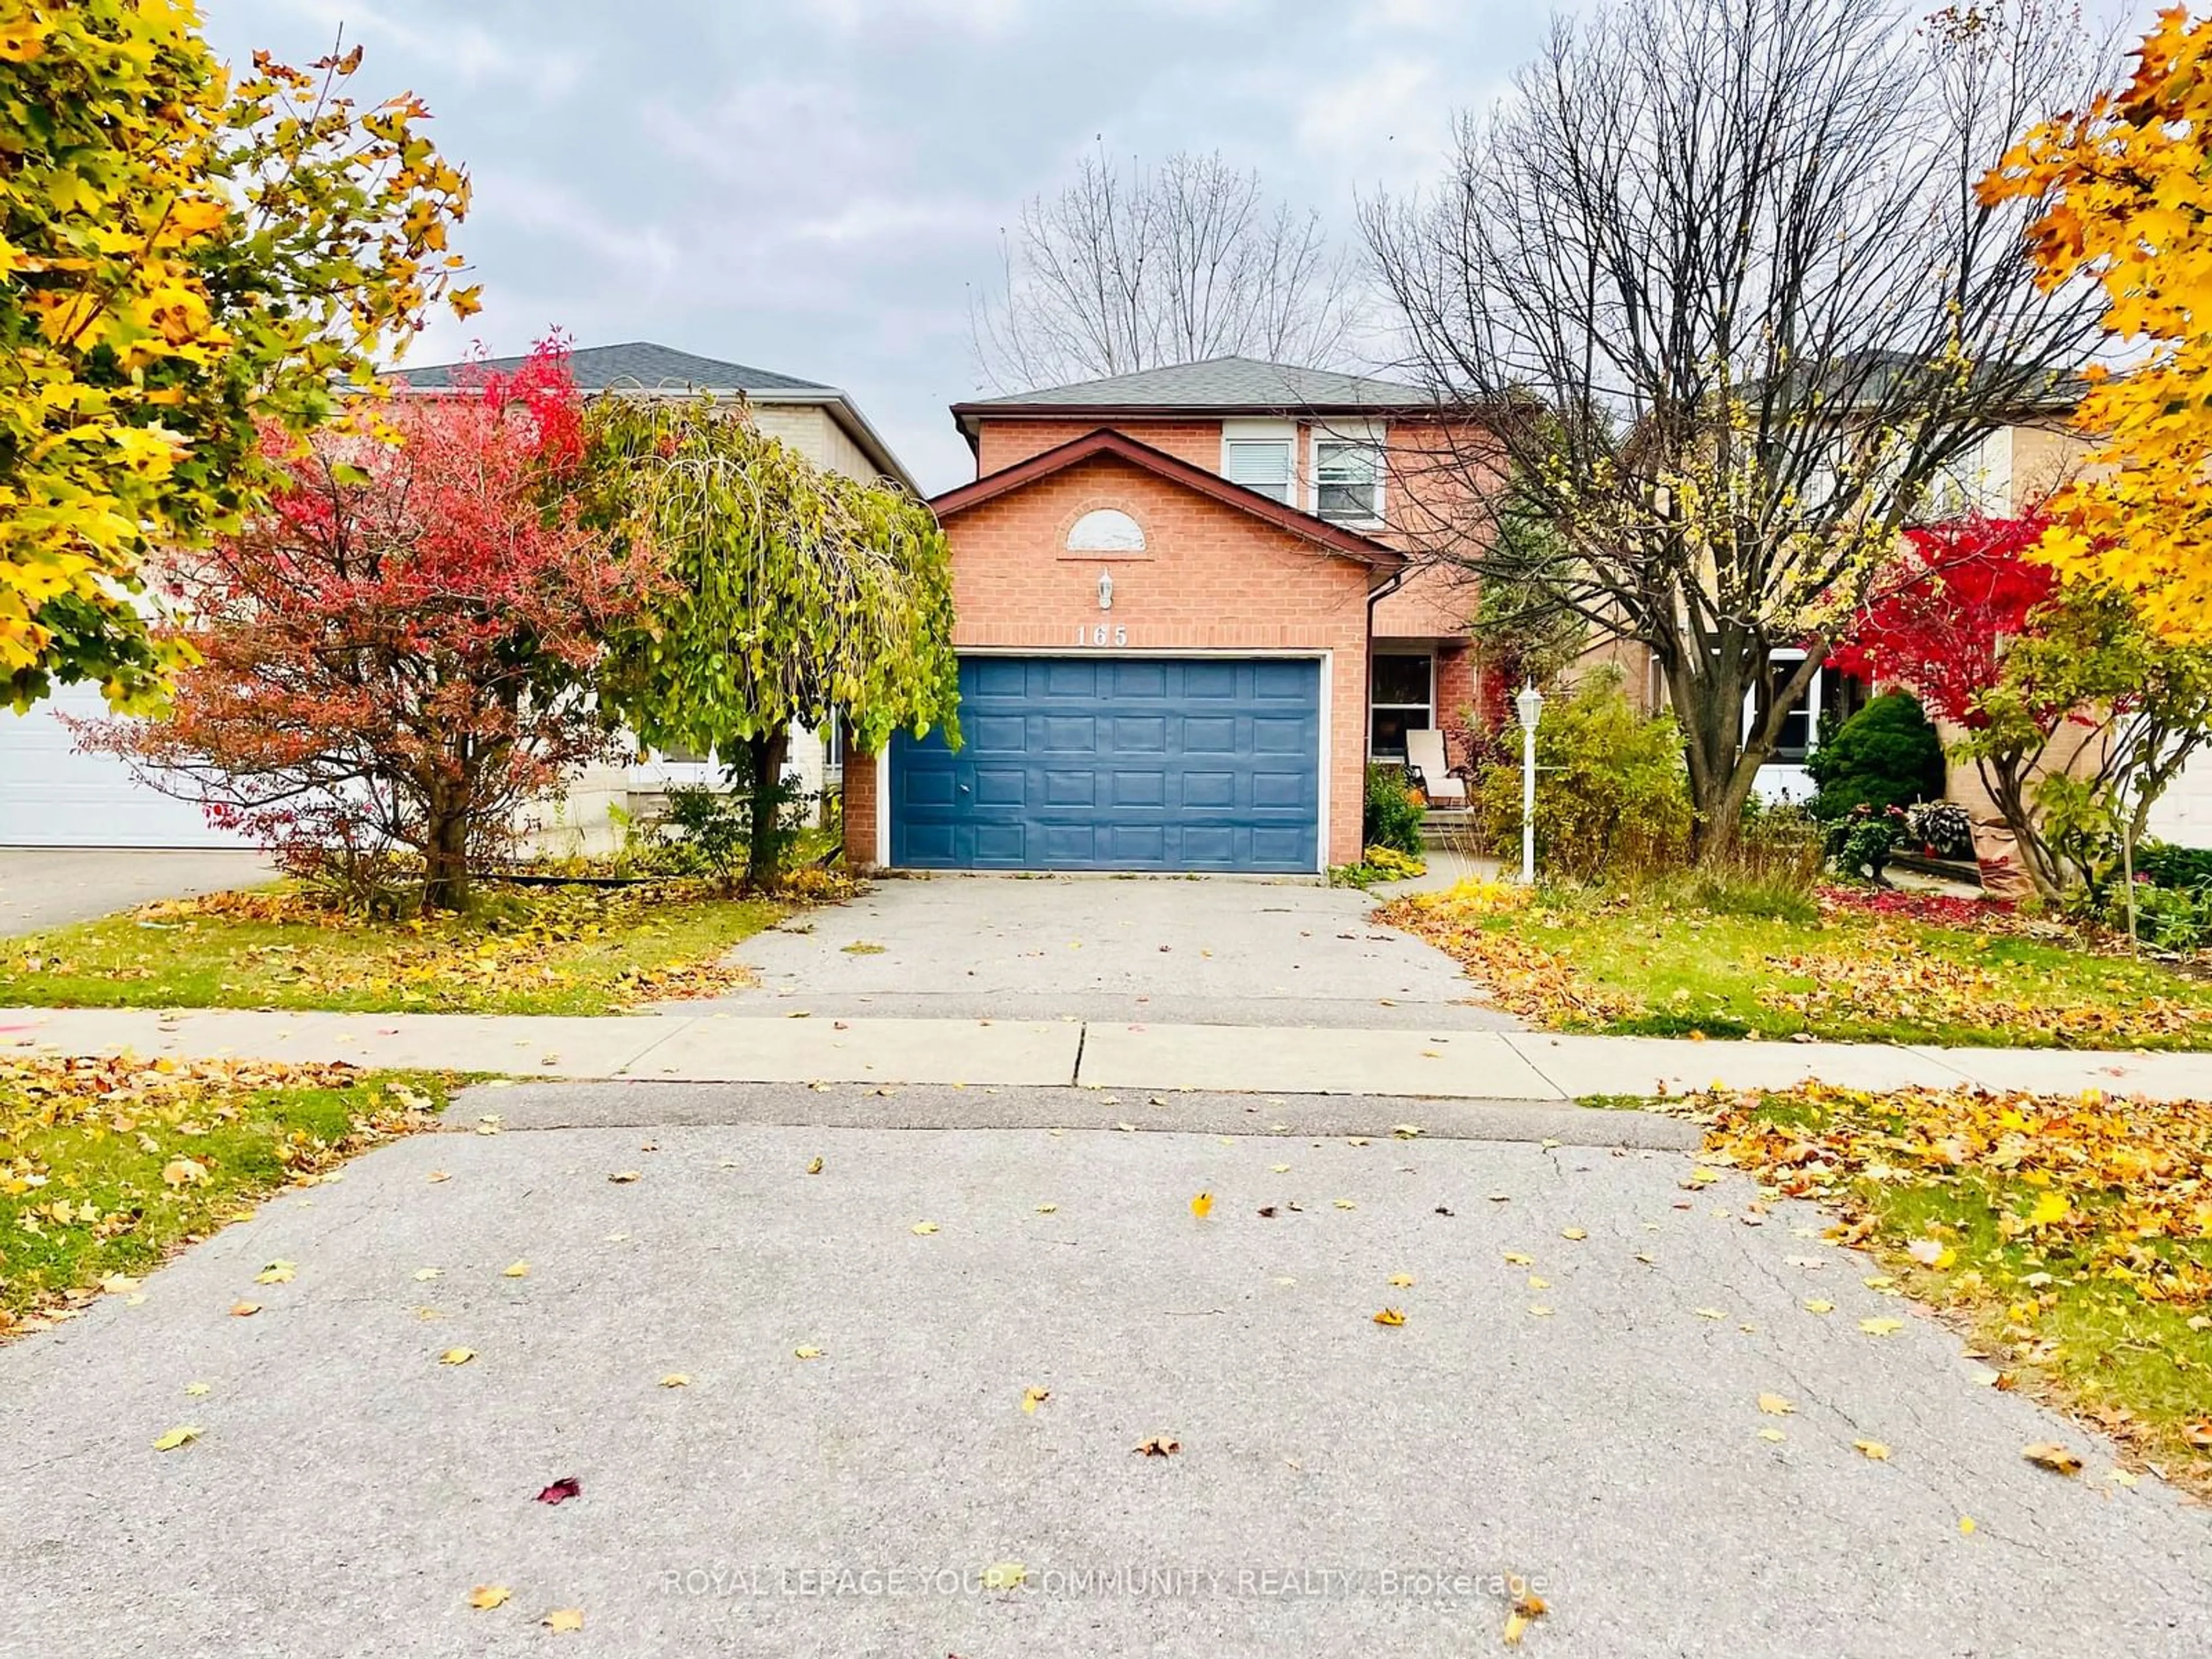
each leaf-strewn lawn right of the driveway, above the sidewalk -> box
[1382,882,2212,1048]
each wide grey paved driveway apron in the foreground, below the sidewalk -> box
[0,1086,2212,1659]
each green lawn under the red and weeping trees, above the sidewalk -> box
[0,882,790,1013]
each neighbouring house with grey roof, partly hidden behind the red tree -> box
[0,343,918,851]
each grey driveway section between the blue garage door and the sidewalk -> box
[717,876,1520,1031]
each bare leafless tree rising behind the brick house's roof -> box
[969,150,1356,392]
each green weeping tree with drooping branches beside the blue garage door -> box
[590,398,960,889]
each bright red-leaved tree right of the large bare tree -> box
[1830,518,2057,728]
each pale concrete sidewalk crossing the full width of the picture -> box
[0,1009,2212,1101]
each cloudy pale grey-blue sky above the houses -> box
[203,0,2148,491]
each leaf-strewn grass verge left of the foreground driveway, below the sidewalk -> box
[0,1055,447,1336]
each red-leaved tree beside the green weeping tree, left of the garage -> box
[82,340,655,909]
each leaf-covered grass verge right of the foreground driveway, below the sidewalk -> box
[1688,1086,2212,1498]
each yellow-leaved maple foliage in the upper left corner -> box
[0,0,476,708]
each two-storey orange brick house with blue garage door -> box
[845,358,1480,872]
